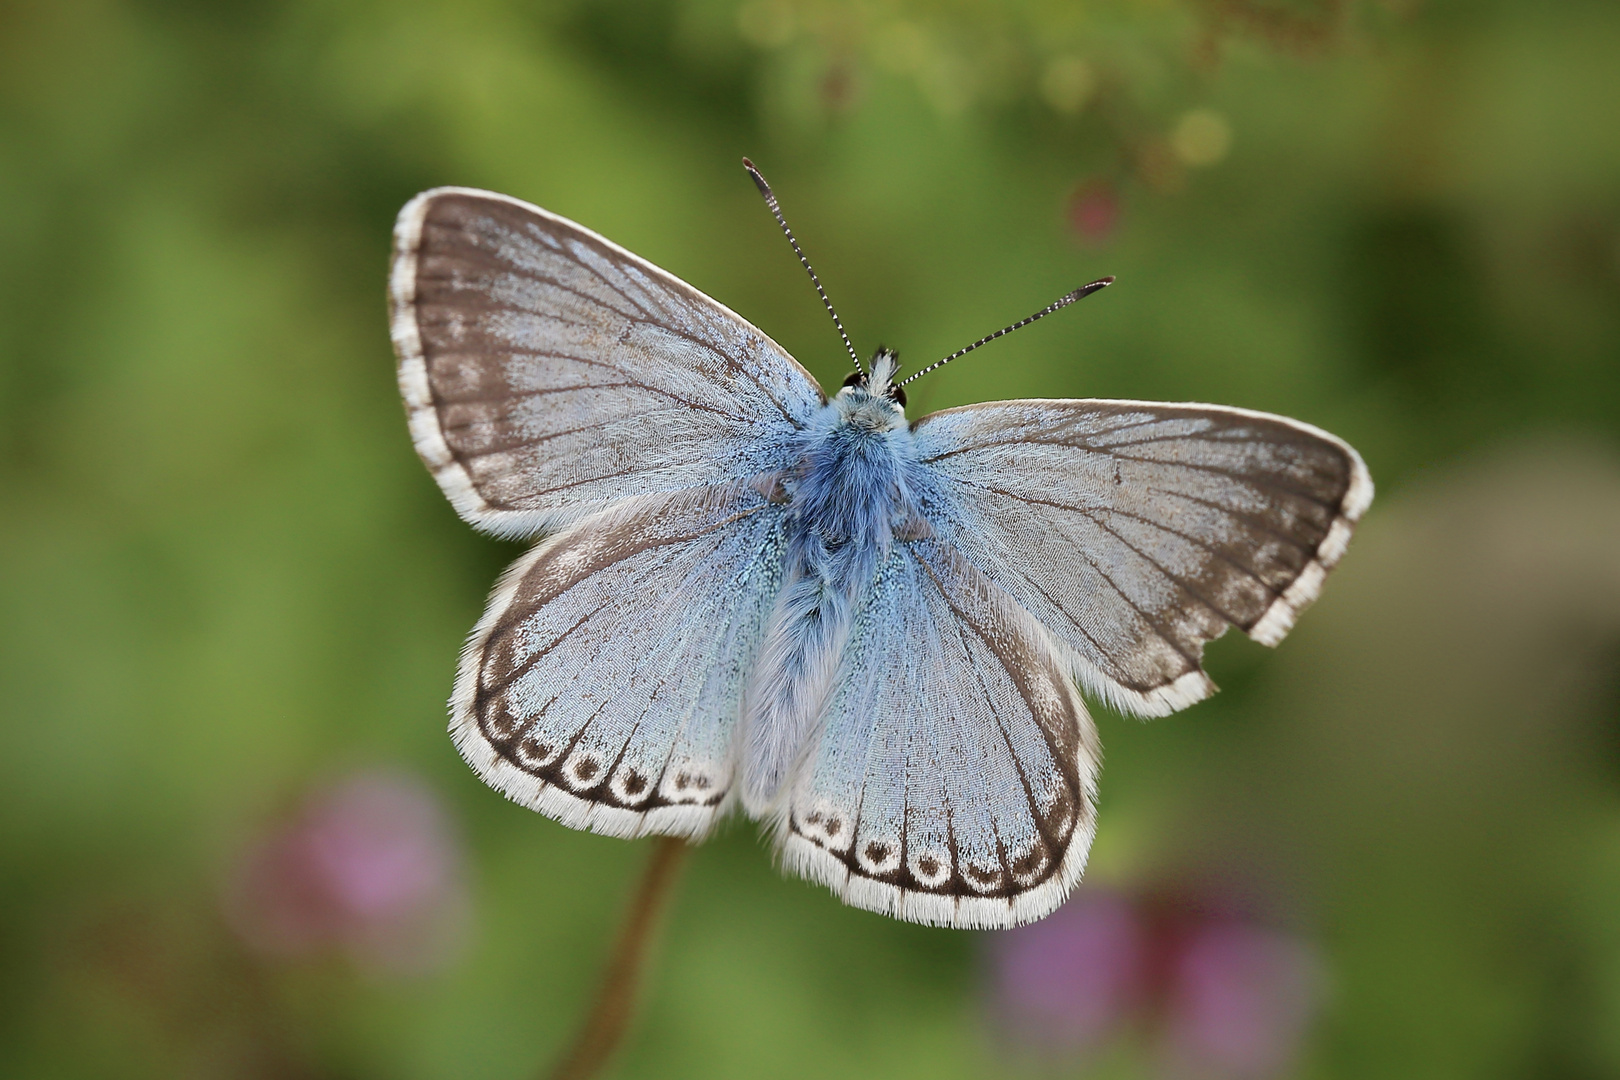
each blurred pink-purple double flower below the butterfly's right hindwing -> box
[988,889,1320,1080]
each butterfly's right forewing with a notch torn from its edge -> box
[914,402,1372,716]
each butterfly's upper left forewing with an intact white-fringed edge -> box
[389,188,823,536]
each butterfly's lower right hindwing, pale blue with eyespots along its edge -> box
[781,539,1100,928]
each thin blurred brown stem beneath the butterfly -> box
[548,836,690,1080]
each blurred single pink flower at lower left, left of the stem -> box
[225,771,467,972]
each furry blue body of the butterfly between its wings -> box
[742,392,915,814]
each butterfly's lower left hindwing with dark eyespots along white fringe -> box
[450,484,782,837]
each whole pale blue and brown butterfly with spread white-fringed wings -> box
[389,162,1372,928]
